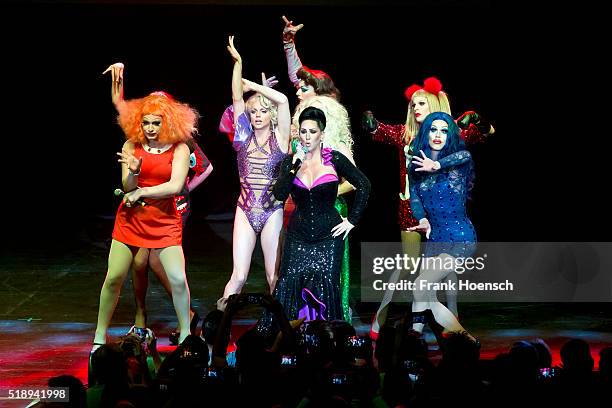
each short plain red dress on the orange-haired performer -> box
[113,144,183,248]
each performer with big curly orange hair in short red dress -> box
[92,70,199,351]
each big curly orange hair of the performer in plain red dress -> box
[118,92,200,144]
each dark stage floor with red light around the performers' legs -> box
[0,217,612,407]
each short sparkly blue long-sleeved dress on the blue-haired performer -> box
[410,150,476,258]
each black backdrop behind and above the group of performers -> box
[0,0,610,249]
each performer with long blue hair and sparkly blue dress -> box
[408,112,476,338]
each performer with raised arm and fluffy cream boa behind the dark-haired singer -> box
[282,16,355,322]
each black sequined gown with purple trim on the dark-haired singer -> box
[263,149,370,326]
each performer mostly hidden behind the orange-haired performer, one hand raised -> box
[104,62,213,345]
